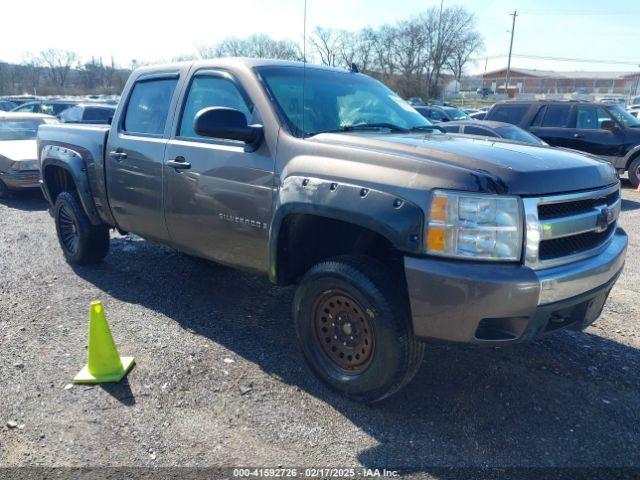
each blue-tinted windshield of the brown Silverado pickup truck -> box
[257,66,435,137]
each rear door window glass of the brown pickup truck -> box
[122,78,178,135]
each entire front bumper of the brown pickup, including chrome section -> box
[404,229,627,343]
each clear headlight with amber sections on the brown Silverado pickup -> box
[427,190,523,261]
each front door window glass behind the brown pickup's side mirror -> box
[178,75,252,138]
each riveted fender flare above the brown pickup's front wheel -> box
[269,176,424,283]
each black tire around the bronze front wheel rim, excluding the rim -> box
[294,262,410,401]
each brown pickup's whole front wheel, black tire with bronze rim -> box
[293,256,424,403]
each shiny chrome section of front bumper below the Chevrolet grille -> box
[535,229,627,305]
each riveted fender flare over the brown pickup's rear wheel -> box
[40,145,103,225]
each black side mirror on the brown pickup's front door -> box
[194,107,262,148]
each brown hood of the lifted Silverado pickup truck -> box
[314,132,618,195]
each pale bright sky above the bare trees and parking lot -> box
[0,0,640,73]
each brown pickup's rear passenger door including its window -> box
[105,72,179,241]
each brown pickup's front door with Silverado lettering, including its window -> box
[164,69,275,272]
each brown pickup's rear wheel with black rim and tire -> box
[53,192,109,265]
